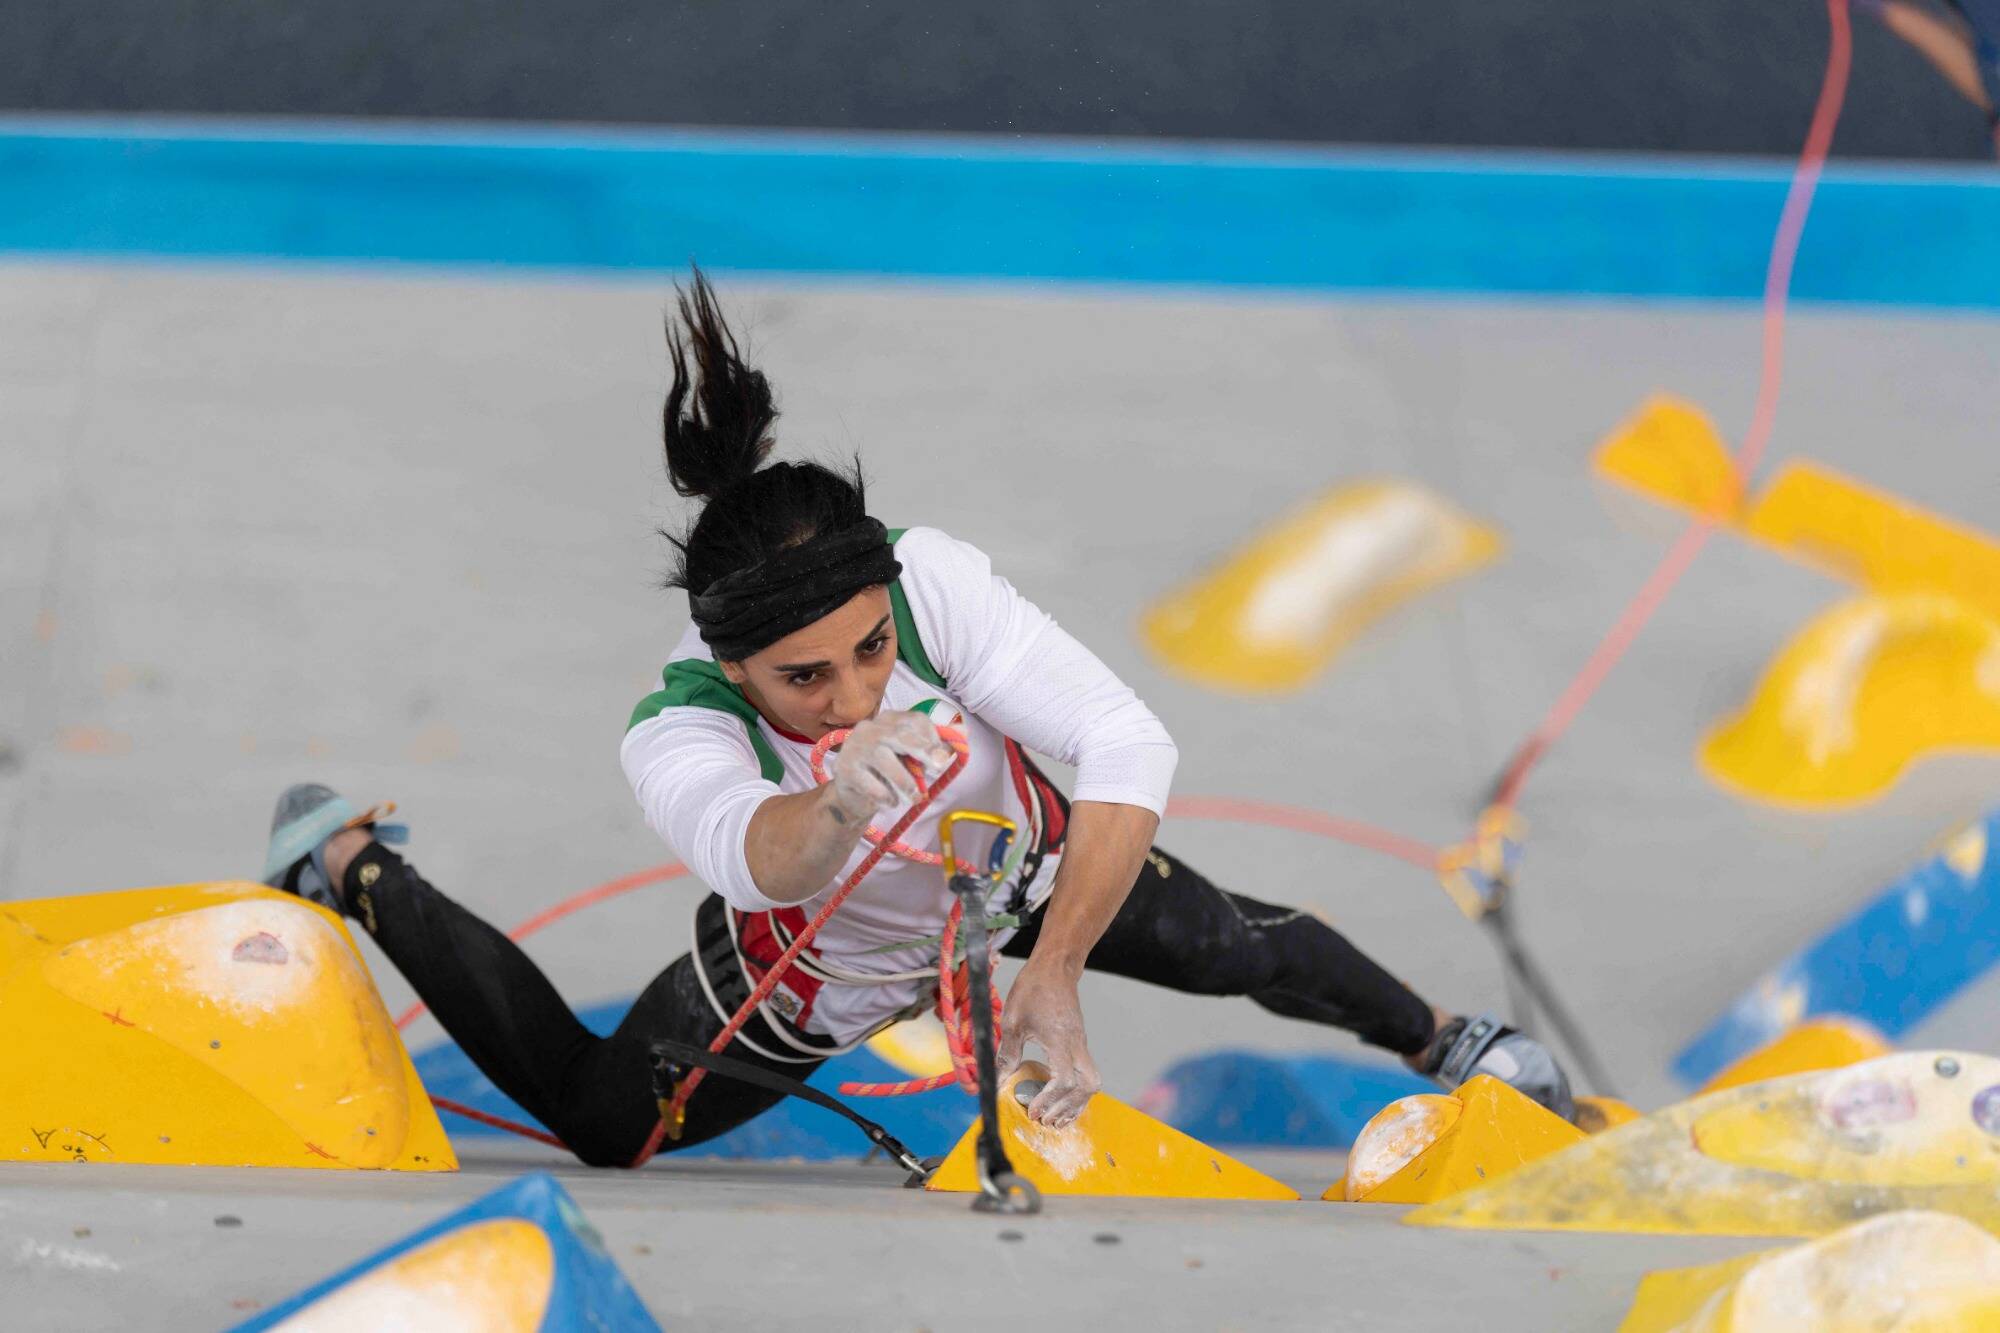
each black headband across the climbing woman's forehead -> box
[688,518,902,662]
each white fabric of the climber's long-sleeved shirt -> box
[620,528,1178,1041]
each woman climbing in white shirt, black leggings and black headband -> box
[266,272,1572,1165]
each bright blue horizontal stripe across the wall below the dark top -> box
[0,118,2000,308]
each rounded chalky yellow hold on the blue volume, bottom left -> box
[274,1217,556,1333]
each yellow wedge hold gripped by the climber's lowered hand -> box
[926,1061,1298,1199]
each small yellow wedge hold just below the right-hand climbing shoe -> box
[1322,1075,1584,1203]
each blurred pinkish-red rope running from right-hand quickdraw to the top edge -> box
[1492,0,1854,809]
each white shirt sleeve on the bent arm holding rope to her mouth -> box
[618,709,784,913]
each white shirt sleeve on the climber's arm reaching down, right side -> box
[896,528,1180,815]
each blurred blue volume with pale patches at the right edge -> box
[1674,811,2000,1087]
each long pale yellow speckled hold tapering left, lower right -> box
[1406,1051,2000,1235]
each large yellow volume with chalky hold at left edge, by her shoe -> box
[0,883,458,1171]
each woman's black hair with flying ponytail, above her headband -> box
[660,268,868,596]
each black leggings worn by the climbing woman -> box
[344,843,1432,1167]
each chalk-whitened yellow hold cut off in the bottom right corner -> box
[1618,1211,2000,1333]
